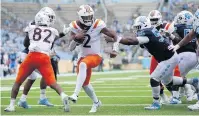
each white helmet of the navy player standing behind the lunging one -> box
[174,10,193,25]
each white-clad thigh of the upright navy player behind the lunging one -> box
[179,52,198,76]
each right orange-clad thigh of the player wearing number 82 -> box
[38,61,56,85]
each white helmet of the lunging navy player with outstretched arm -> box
[133,16,151,31]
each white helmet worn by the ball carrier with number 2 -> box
[77,5,94,26]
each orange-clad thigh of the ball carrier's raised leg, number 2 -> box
[81,55,102,68]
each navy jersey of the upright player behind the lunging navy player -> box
[174,24,197,53]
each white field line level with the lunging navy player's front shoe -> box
[1,104,191,107]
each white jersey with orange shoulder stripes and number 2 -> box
[69,19,106,57]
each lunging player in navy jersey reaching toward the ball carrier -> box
[114,16,199,110]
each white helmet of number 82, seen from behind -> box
[35,12,51,26]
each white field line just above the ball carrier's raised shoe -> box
[2,90,152,93]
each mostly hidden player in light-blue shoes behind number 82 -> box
[18,7,69,109]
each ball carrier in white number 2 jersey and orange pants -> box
[69,5,121,112]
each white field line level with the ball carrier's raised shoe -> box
[1,96,152,99]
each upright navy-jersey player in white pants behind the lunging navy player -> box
[170,11,197,104]
